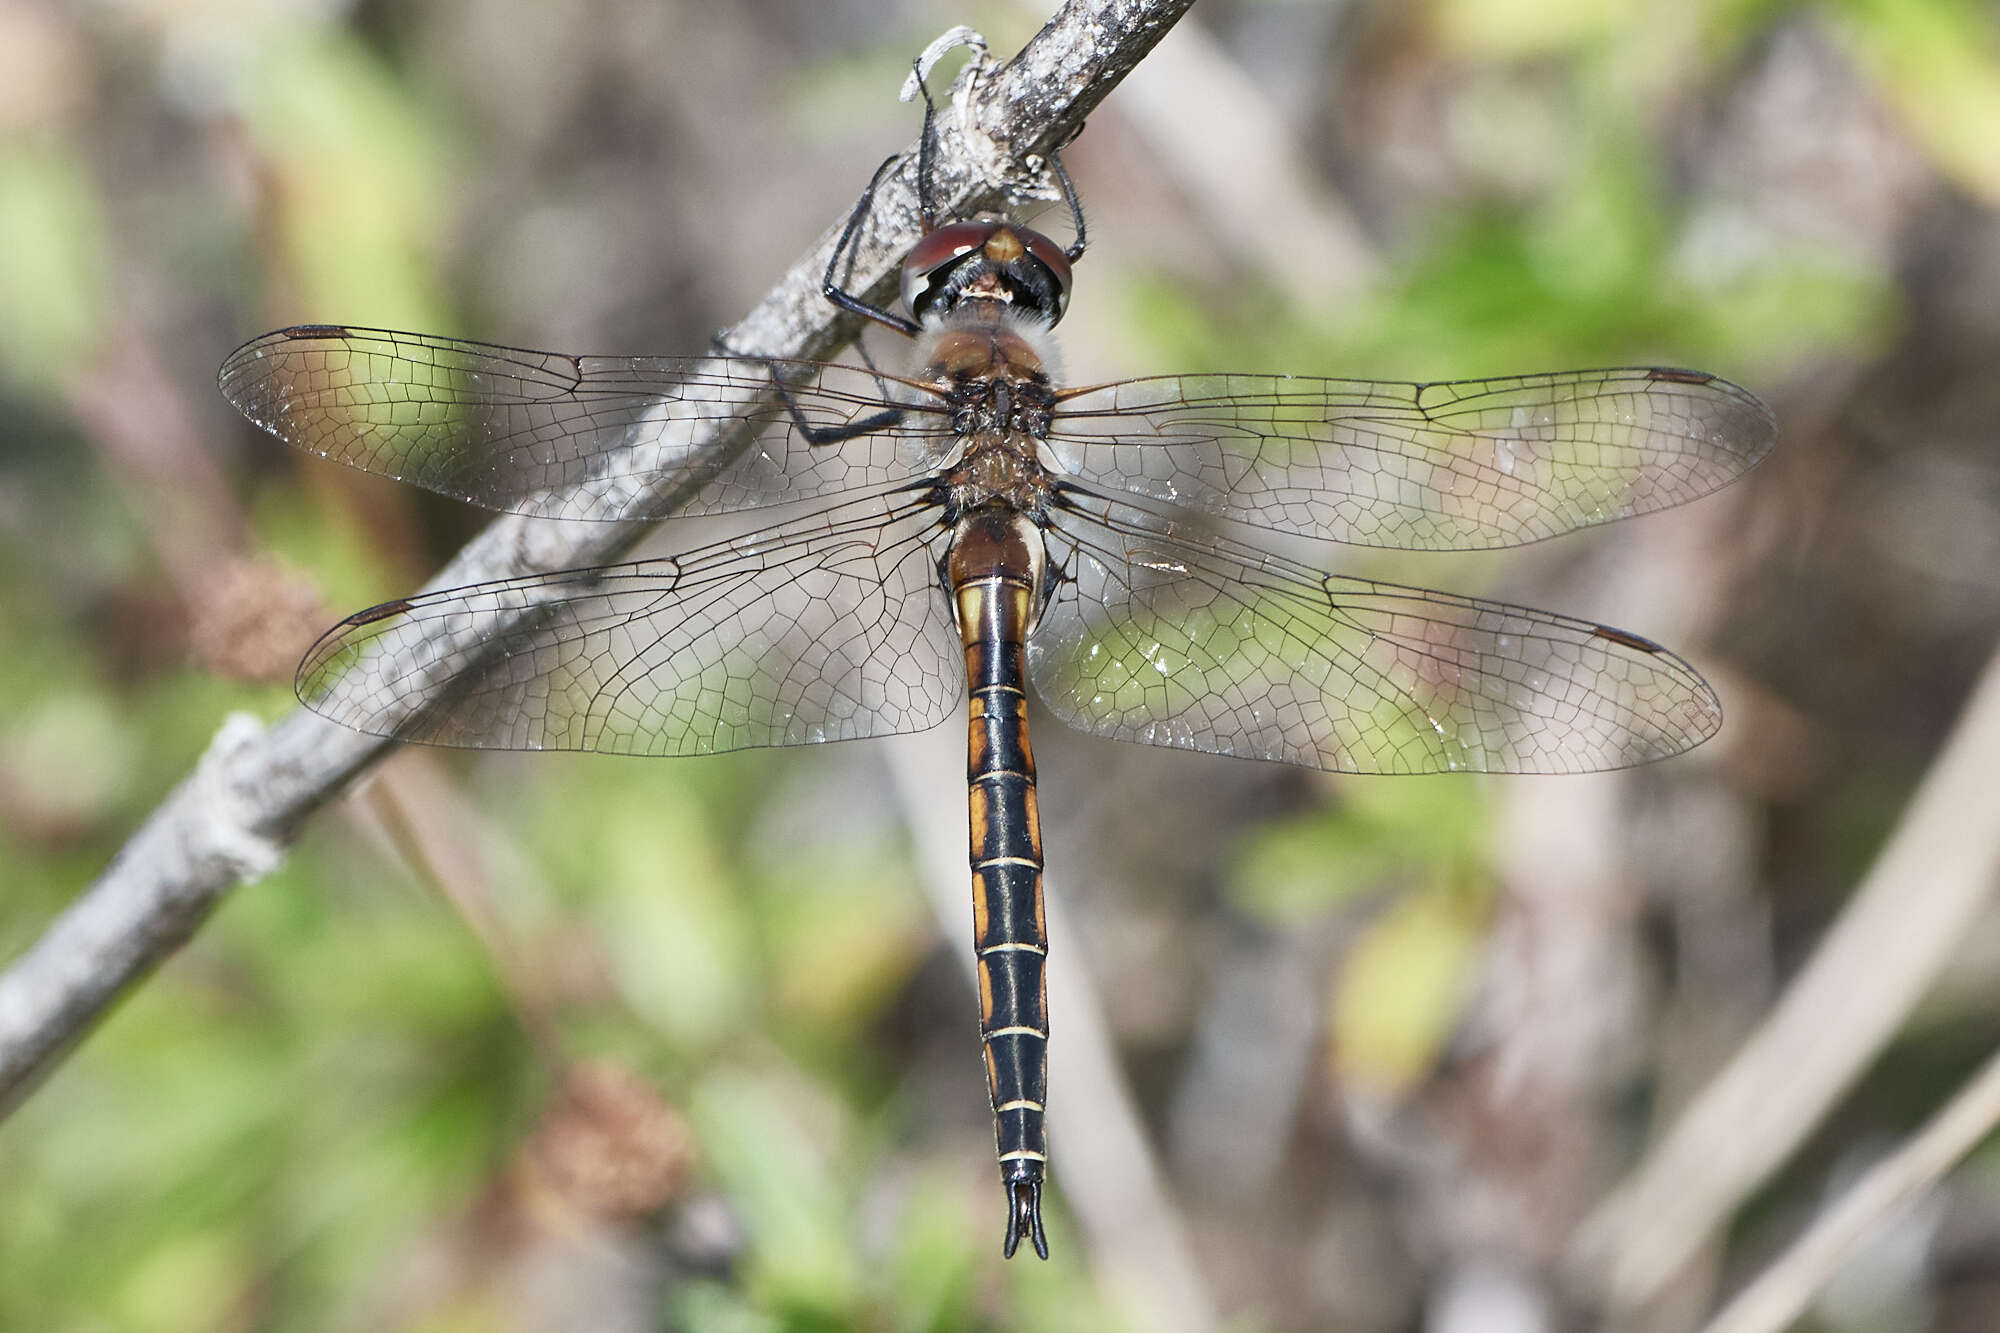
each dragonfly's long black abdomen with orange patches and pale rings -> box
[948,506,1048,1259]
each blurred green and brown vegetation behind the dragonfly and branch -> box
[0,0,2000,1333]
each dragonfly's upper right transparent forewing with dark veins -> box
[1050,368,1778,550]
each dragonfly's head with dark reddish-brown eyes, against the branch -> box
[902,218,1070,324]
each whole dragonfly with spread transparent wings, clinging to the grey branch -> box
[218,106,1776,1259]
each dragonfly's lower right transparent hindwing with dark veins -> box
[1028,492,1722,773]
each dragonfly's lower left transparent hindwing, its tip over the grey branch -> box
[298,498,964,755]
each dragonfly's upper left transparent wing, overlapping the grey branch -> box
[218,324,944,518]
